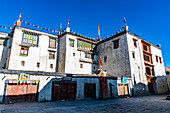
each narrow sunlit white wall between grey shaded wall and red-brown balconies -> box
[127,34,147,85]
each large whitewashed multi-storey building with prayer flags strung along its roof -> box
[0,17,167,101]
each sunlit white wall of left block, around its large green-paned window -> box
[7,26,58,72]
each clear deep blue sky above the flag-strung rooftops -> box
[0,0,170,66]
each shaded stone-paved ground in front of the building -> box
[0,95,170,113]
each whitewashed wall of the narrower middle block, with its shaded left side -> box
[58,29,97,74]
